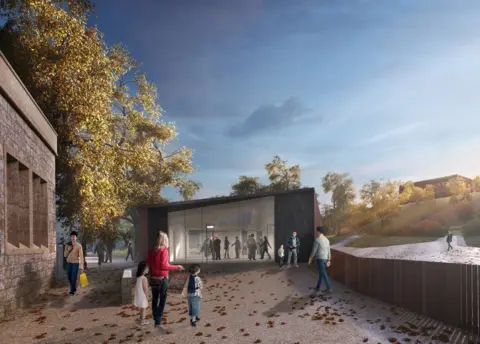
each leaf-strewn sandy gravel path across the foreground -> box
[0,264,476,344]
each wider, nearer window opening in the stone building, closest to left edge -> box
[6,154,30,248]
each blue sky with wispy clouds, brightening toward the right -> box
[92,0,480,203]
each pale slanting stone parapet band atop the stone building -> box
[0,51,57,155]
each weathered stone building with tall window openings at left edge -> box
[0,53,57,318]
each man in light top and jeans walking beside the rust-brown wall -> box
[308,227,332,293]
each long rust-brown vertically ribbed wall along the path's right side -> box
[328,250,480,335]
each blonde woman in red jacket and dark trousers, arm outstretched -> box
[147,232,183,327]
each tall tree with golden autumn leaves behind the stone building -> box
[0,0,200,233]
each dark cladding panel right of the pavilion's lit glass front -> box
[275,189,315,263]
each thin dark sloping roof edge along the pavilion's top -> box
[138,188,315,212]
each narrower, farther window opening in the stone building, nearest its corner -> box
[32,173,48,247]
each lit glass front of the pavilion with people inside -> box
[168,197,275,264]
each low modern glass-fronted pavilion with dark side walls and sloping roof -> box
[137,188,319,264]
